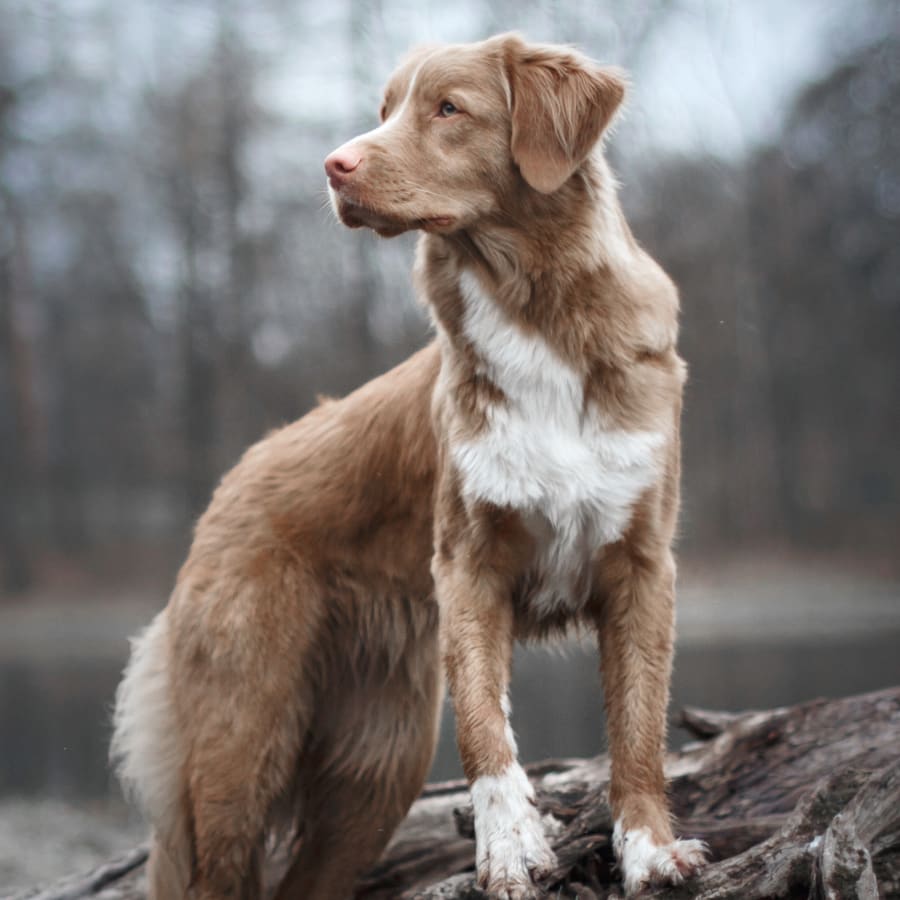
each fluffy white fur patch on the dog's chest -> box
[452,272,665,613]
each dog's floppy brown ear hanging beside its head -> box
[504,35,625,194]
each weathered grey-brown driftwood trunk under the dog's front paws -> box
[8,688,900,900]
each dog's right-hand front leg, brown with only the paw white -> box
[597,544,705,894]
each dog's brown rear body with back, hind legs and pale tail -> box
[112,347,441,900]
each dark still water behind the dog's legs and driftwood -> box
[0,628,900,802]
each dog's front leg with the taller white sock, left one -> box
[434,552,556,900]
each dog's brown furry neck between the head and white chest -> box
[416,153,665,374]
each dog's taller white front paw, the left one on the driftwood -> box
[472,764,556,900]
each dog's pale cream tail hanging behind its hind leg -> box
[110,610,191,900]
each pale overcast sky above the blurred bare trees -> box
[0,0,892,174]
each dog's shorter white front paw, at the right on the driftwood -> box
[613,823,707,896]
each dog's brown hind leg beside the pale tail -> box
[167,566,316,900]
